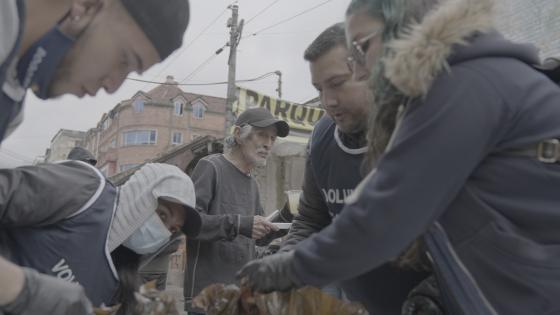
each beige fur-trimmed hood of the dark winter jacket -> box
[383,0,539,97]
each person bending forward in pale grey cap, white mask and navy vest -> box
[0,161,201,314]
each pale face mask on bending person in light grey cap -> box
[123,213,171,255]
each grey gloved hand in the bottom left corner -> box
[0,268,93,315]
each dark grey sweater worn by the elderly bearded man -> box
[184,154,264,311]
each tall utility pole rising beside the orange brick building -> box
[225,4,243,136]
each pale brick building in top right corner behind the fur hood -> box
[497,0,560,58]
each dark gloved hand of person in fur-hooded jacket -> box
[237,251,303,293]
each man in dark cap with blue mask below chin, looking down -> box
[0,0,189,142]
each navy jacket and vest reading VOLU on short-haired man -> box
[281,116,426,314]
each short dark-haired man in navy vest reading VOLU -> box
[274,23,425,314]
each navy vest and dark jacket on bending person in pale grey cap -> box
[0,161,119,306]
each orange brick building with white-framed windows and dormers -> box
[83,76,225,176]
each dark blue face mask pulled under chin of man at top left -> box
[17,26,74,99]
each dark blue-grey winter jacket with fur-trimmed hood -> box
[292,0,560,315]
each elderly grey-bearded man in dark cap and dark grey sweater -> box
[184,108,290,314]
